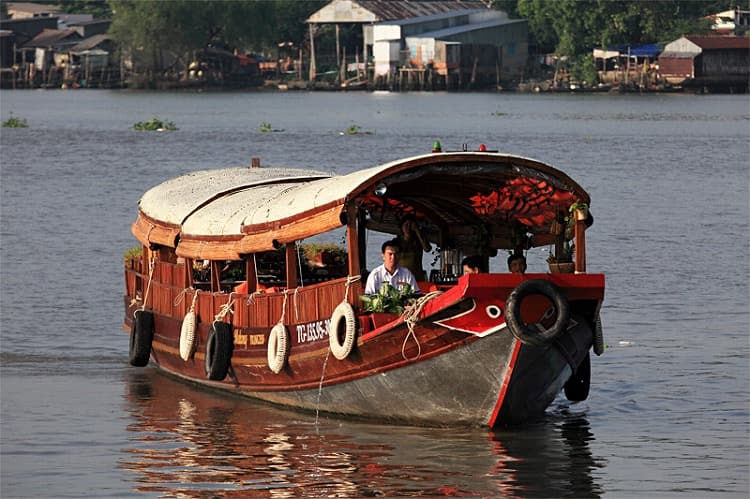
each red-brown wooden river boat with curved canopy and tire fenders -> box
[124,151,604,427]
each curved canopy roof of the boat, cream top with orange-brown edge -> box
[132,152,590,259]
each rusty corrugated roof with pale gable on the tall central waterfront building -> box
[306,0,487,24]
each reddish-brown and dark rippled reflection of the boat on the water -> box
[119,369,602,498]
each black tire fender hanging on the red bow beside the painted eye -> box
[505,279,570,347]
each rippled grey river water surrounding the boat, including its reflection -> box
[0,90,750,498]
